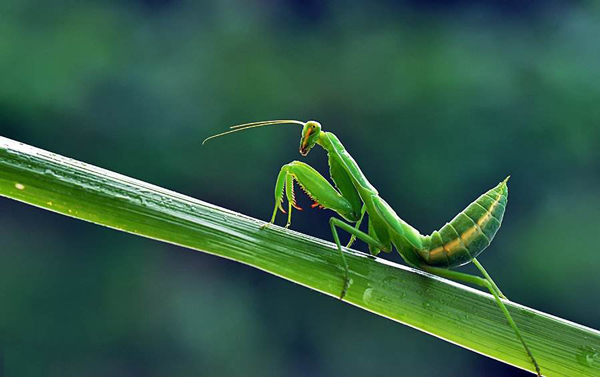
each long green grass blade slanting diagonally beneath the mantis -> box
[0,137,600,376]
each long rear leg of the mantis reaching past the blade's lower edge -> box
[420,259,542,376]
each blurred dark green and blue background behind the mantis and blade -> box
[0,0,600,377]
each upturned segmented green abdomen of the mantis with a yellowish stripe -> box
[419,178,508,268]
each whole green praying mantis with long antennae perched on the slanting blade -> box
[202,120,541,376]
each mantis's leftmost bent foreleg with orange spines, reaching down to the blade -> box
[265,161,361,226]
